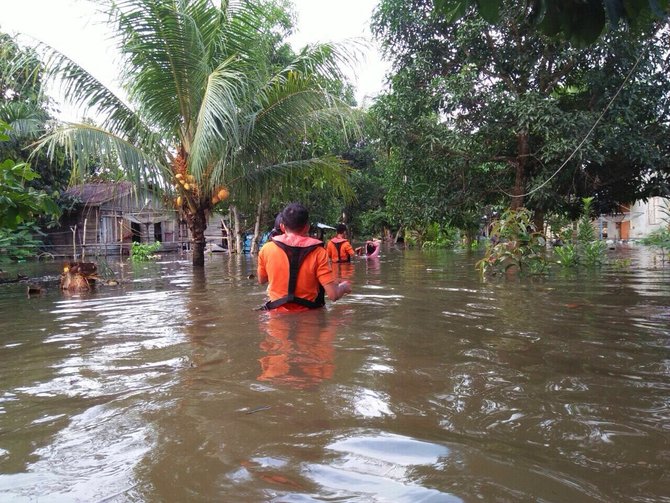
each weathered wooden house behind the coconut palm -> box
[47,181,189,257]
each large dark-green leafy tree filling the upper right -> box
[373,0,670,228]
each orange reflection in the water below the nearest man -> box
[258,311,335,388]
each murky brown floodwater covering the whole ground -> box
[0,248,670,503]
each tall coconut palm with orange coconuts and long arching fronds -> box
[32,0,350,266]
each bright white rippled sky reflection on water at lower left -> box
[0,265,192,501]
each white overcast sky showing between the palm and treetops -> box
[0,0,390,120]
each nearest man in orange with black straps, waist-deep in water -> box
[258,203,351,311]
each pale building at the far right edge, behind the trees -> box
[596,197,670,241]
